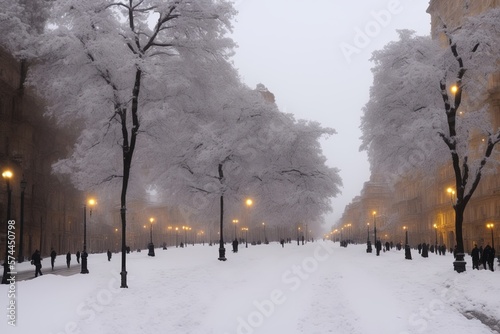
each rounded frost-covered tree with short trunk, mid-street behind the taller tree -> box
[143,68,341,260]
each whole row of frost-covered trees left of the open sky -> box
[0,0,341,288]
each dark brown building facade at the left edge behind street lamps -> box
[0,50,83,259]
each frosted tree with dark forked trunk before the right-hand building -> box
[361,9,500,271]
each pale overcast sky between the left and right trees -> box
[229,0,430,227]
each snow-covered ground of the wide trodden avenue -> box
[0,241,500,334]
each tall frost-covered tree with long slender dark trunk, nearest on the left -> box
[31,0,234,288]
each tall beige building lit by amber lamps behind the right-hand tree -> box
[339,0,500,252]
